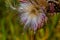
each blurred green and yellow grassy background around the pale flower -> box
[0,0,60,40]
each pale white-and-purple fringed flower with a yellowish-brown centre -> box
[19,2,46,32]
